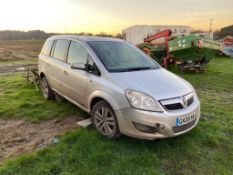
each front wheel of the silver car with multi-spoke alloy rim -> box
[91,101,121,139]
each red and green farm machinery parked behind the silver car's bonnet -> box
[138,30,221,72]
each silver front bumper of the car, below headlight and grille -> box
[115,99,200,140]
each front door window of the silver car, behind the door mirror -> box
[67,41,88,64]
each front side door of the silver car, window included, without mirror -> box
[62,41,89,106]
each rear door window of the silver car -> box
[53,40,70,61]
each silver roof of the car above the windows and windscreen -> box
[48,35,124,42]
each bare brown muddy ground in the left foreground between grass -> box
[0,116,80,163]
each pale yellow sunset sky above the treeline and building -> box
[0,0,233,34]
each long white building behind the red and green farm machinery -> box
[122,25,191,45]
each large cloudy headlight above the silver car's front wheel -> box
[125,90,163,112]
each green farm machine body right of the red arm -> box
[168,35,221,72]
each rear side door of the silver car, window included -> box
[47,39,70,93]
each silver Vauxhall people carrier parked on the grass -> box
[39,35,200,139]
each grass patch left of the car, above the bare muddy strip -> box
[0,75,87,122]
